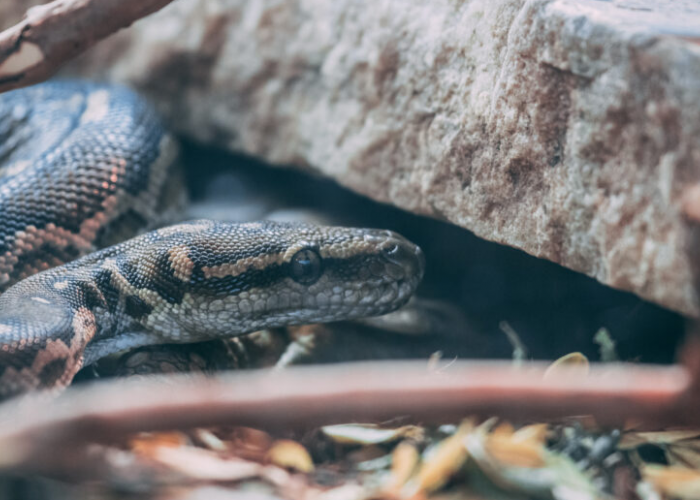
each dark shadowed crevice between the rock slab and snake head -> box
[179,143,684,363]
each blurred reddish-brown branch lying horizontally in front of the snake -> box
[0,362,700,471]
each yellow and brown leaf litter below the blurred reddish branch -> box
[19,330,700,500]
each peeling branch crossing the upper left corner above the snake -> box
[0,0,172,92]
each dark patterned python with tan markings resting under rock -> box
[0,80,425,400]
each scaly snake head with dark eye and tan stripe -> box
[151,221,425,335]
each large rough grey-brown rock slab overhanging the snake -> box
[23,0,700,316]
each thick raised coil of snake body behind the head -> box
[0,82,182,290]
